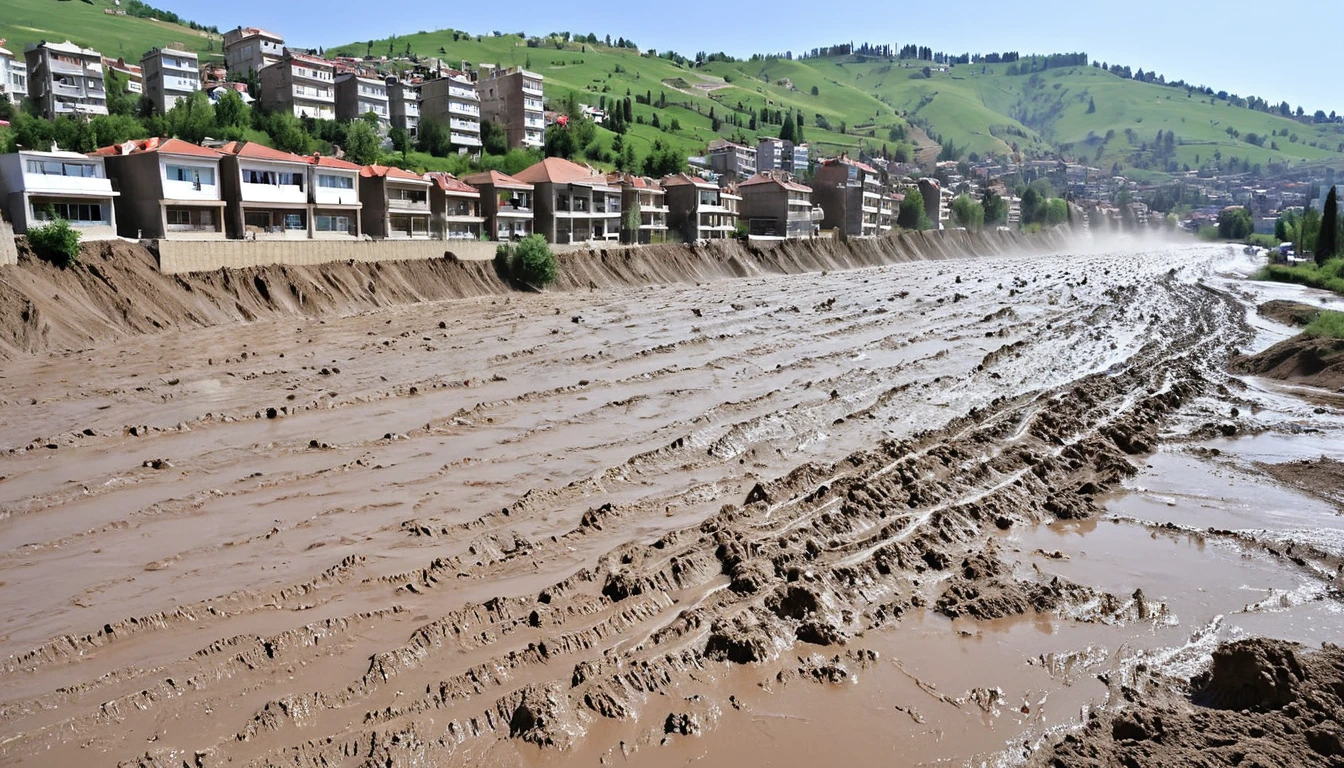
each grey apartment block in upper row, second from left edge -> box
[23,40,108,120]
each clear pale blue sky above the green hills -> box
[162,0,1344,113]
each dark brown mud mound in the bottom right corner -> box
[1032,639,1344,768]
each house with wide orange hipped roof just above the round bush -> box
[515,157,621,243]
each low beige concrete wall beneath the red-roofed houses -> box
[151,238,585,274]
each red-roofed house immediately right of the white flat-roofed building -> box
[94,139,224,239]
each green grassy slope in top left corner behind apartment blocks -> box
[0,0,220,63]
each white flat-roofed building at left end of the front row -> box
[0,149,117,239]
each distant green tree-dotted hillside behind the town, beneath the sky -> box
[328,30,1344,175]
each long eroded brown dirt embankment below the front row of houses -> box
[0,231,1066,359]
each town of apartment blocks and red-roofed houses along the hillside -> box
[0,27,1335,245]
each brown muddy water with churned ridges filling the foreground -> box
[0,245,1344,765]
